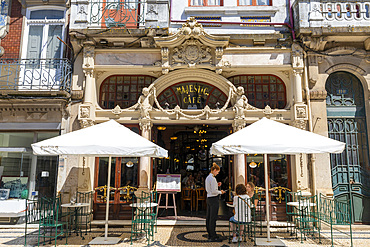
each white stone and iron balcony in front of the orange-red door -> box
[71,0,169,30]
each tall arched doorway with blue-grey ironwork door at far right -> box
[326,72,370,222]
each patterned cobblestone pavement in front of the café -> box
[0,226,370,247]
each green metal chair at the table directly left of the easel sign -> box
[131,191,157,245]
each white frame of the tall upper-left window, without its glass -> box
[21,6,67,59]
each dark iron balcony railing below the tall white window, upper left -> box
[0,59,72,93]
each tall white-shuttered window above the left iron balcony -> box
[22,9,65,59]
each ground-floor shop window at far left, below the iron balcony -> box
[0,132,59,199]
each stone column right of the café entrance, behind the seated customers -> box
[233,119,246,187]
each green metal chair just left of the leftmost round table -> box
[37,197,68,246]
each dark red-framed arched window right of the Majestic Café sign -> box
[229,75,286,109]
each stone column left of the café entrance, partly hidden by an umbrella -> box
[139,119,153,190]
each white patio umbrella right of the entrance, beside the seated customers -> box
[211,118,345,245]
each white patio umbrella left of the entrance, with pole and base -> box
[31,120,168,244]
